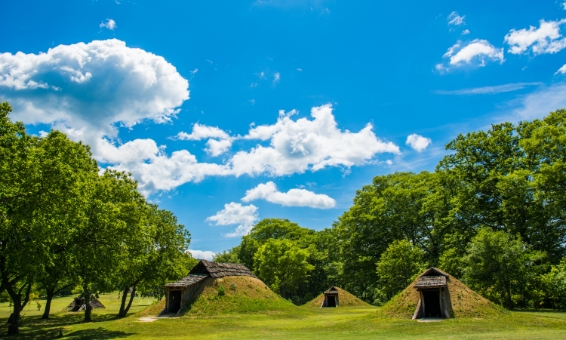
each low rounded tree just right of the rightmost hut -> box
[464,228,544,309]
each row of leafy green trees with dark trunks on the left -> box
[0,103,195,334]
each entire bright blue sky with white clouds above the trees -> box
[0,0,566,257]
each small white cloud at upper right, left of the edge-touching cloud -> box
[436,39,505,71]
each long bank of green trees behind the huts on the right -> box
[215,110,566,309]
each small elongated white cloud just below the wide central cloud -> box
[242,182,336,209]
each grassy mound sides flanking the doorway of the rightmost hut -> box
[378,275,507,319]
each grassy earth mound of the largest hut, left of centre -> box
[181,276,296,316]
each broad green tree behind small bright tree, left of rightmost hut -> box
[333,172,443,301]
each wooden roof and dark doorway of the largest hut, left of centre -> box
[162,260,257,314]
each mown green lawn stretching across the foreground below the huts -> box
[0,293,566,339]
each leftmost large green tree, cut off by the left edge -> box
[0,103,98,334]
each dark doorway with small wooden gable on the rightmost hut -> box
[413,268,452,319]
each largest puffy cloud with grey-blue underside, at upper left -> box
[0,39,189,137]
